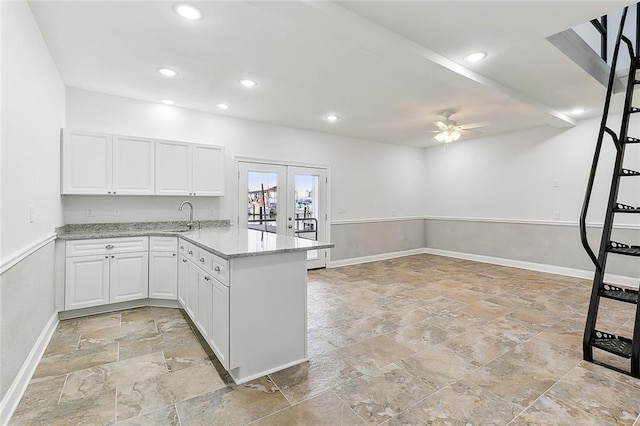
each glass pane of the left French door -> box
[247,171,278,233]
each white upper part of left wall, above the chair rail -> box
[0,2,65,264]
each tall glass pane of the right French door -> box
[294,174,319,259]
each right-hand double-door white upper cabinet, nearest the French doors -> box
[156,141,224,196]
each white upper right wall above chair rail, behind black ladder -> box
[424,112,640,224]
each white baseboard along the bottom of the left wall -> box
[0,312,59,425]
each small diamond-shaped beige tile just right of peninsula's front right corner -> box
[339,336,415,373]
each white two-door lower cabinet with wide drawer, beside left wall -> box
[64,237,149,311]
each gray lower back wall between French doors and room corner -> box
[331,219,426,262]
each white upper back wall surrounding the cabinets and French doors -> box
[63,88,425,223]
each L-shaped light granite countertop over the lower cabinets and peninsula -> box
[56,221,334,259]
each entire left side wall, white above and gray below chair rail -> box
[0,2,65,412]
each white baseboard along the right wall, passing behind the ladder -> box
[423,248,639,289]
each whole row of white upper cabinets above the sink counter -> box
[62,130,225,196]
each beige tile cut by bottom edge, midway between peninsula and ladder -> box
[411,380,521,425]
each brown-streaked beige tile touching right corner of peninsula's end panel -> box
[269,351,361,404]
